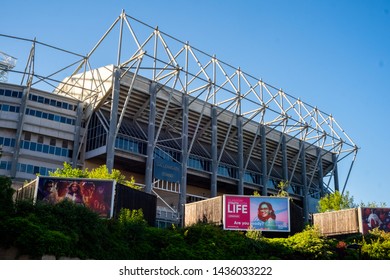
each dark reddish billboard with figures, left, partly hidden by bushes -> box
[34,176,115,218]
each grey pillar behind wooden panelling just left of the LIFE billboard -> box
[210,105,218,197]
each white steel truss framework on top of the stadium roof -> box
[0,11,358,199]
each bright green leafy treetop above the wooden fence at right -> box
[317,191,356,213]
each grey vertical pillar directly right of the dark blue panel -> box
[179,93,189,226]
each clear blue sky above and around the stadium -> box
[0,0,390,207]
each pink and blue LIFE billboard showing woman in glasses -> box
[223,195,290,232]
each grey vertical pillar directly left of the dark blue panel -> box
[145,82,157,193]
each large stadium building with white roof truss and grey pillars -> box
[0,12,358,224]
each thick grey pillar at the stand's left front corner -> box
[106,67,120,173]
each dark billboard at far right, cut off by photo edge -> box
[359,207,390,234]
